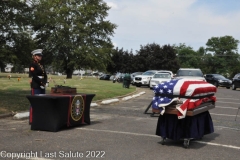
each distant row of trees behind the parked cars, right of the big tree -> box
[107,36,240,78]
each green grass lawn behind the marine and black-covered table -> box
[0,73,136,114]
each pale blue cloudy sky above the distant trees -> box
[105,0,240,53]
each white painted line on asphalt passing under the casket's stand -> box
[76,128,240,149]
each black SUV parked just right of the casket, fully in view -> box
[205,74,232,89]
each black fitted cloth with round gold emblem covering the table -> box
[27,94,95,132]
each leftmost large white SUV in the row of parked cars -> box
[133,70,158,87]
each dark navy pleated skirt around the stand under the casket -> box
[156,111,214,140]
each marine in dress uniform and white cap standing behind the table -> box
[29,49,47,124]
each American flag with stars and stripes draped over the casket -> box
[152,79,217,119]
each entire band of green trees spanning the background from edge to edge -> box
[0,0,240,78]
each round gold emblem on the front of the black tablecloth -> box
[71,95,84,121]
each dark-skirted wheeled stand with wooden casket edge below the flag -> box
[155,101,215,148]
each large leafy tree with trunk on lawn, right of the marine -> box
[32,0,116,78]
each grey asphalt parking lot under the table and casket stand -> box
[0,87,240,160]
